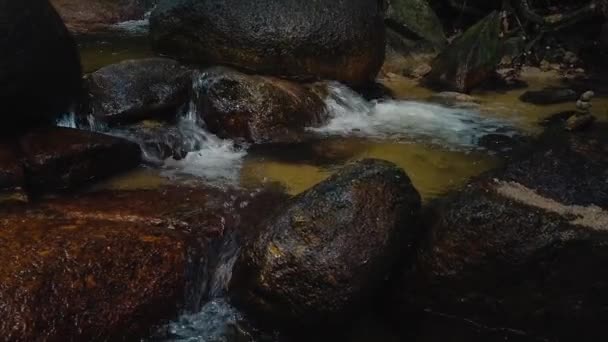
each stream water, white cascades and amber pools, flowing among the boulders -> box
[72,21,608,342]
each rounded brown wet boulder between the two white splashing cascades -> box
[195,67,326,143]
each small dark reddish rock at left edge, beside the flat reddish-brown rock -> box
[0,142,27,205]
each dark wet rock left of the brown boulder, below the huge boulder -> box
[84,58,192,124]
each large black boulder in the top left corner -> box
[0,0,82,132]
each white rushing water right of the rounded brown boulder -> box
[312,83,513,149]
